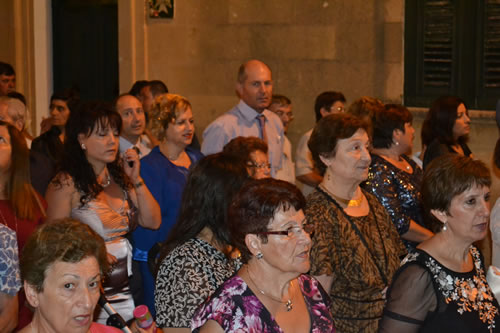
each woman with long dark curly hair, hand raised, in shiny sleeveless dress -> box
[46,103,161,321]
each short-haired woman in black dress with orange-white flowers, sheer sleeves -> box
[380,154,500,333]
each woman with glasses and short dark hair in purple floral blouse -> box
[191,178,335,333]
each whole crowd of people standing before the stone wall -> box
[0,56,500,333]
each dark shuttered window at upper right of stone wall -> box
[404,0,500,109]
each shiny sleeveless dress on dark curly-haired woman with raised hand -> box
[71,191,135,324]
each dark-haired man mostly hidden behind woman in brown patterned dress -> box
[295,91,345,196]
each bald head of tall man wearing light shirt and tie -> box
[236,60,273,113]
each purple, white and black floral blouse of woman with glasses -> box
[191,275,335,333]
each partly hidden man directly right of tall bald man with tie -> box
[269,95,295,184]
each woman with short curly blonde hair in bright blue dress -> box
[132,94,203,315]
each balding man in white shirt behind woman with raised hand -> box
[115,94,153,158]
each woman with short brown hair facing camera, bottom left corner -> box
[20,219,120,333]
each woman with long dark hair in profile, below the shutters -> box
[422,96,472,169]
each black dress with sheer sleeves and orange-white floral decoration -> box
[379,246,500,333]
